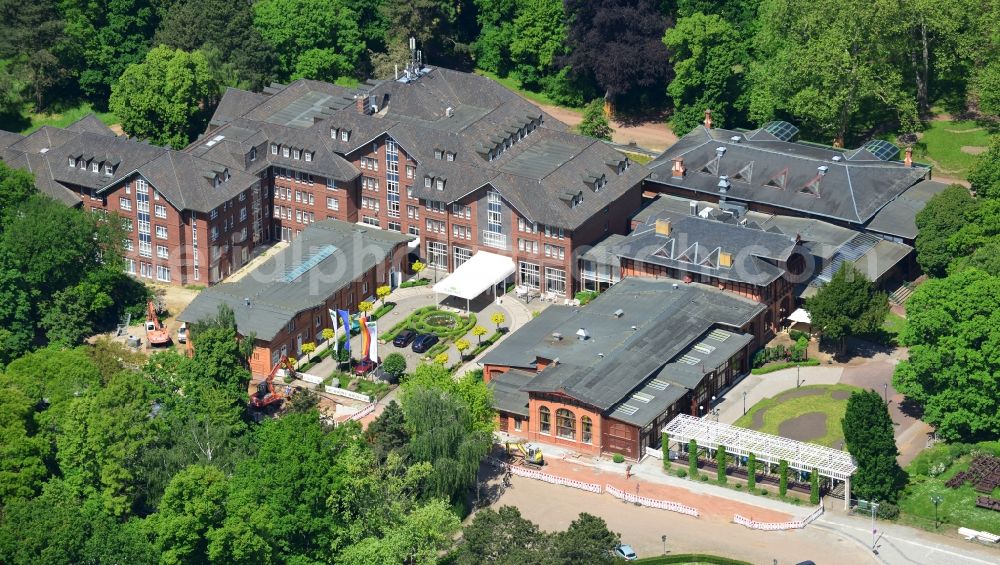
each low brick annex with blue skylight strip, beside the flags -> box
[178,219,412,375]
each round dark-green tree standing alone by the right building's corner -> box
[805,262,889,352]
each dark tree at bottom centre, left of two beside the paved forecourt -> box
[457,506,552,565]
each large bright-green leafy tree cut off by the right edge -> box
[893,268,1000,441]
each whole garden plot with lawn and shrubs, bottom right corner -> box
[899,442,1000,533]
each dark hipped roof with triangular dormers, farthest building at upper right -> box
[649,126,930,224]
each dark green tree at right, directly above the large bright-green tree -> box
[915,185,980,277]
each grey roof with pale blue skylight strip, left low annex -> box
[178,220,412,340]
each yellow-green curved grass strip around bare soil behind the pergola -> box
[735,385,858,447]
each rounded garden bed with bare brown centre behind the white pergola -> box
[734,385,858,449]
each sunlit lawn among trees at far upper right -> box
[886,120,990,178]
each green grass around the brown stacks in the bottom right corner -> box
[899,446,1000,533]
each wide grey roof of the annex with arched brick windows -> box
[482,278,764,410]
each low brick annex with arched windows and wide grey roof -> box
[480,278,766,459]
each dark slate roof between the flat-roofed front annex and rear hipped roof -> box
[612,208,796,286]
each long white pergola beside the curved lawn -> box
[663,414,858,509]
